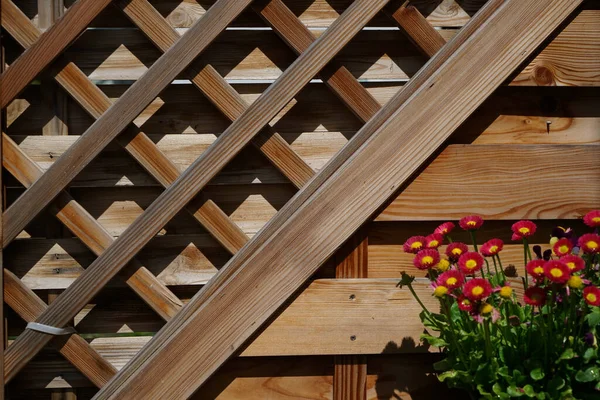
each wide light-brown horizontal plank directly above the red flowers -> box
[376,145,600,221]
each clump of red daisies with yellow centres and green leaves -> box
[399,211,600,399]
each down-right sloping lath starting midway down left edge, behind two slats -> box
[2,133,183,321]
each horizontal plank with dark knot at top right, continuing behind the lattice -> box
[7,10,600,86]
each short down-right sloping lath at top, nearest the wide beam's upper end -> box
[391,6,446,57]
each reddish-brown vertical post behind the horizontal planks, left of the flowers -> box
[333,228,369,400]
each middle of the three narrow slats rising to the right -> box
[3,0,251,245]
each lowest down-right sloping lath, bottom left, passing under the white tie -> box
[3,269,117,387]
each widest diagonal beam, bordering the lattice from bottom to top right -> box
[95,0,581,399]
